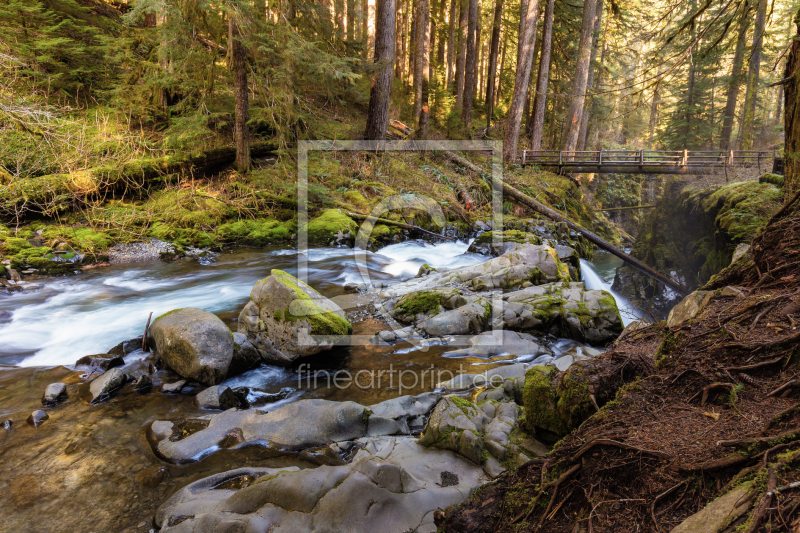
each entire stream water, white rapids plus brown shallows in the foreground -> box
[0,241,636,533]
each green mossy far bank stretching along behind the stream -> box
[0,123,619,273]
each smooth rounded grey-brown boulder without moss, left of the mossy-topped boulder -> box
[150,307,233,385]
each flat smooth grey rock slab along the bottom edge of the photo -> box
[155,437,488,533]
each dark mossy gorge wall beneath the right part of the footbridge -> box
[632,180,782,287]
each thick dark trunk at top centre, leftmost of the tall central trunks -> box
[365,0,396,140]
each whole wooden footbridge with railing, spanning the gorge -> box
[522,150,783,174]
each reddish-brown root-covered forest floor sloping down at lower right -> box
[440,193,800,533]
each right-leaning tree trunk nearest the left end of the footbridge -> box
[503,0,539,163]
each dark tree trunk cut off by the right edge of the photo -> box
[783,15,800,202]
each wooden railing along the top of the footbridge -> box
[522,150,774,167]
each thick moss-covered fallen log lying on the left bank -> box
[0,142,278,220]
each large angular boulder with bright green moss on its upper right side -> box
[239,270,353,366]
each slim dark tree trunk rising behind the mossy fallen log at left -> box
[228,13,250,173]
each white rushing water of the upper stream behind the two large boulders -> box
[0,241,487,366]
